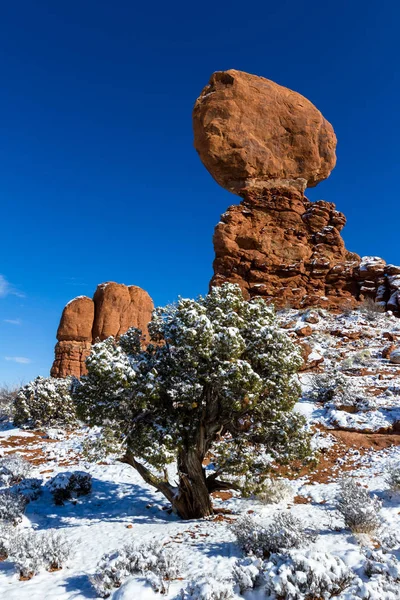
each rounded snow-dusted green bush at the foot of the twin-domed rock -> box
[14,377,76,427]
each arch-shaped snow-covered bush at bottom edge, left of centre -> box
[90,541,181,598]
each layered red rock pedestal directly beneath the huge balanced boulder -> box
[211,189,361,307]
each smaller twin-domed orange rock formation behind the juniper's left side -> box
[50,282,153,377]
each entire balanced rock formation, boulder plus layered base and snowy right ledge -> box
[193,70,400,312]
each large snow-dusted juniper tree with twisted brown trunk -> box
[74,284,310,519]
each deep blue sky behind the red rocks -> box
[0,0,400,383]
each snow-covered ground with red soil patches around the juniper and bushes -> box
[0,310,400,600]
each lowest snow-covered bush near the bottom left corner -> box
[8,531,71,579]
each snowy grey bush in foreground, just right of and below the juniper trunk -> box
[232,512,312,557]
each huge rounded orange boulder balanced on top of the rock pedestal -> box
[193,69,336,194]
